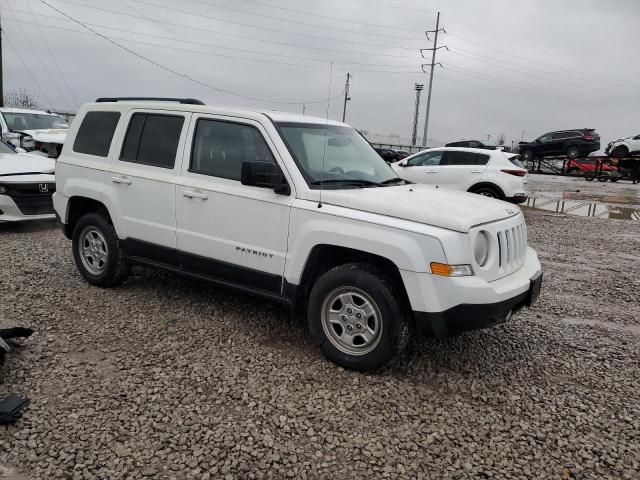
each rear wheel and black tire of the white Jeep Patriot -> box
[72,213,131,288]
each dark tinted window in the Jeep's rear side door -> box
[120,113,184,168]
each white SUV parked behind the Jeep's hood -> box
[391,147,527,203]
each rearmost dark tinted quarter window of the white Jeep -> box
[73,112,120,157]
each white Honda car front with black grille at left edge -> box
[0,142,56,223]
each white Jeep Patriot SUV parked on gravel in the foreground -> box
[54,98,542,371]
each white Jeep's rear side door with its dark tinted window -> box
[107,110,191,266]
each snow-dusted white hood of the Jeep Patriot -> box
[322,184,520,233]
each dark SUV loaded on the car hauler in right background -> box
[519,128,600,160]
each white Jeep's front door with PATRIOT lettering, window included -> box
[176,115,294,295]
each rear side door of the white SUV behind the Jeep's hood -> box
[437,150,490,191]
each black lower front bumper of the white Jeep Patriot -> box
[414,272,542,338]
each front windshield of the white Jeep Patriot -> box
[278,123,401,188]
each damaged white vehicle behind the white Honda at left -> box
[0,108,69,158]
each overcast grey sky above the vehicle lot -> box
[0,0,640,148]
